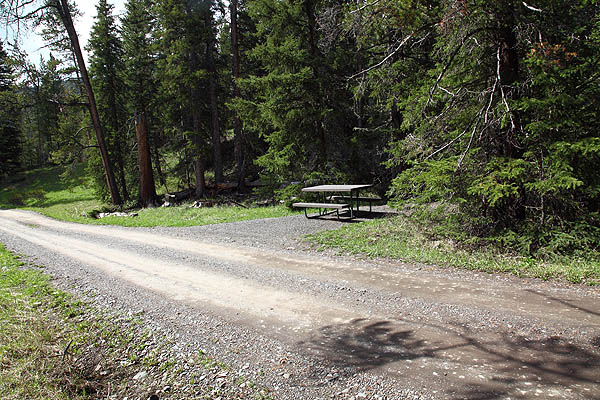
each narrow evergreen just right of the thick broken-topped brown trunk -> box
[156,0,214,197]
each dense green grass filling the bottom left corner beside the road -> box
[0,245,97,399]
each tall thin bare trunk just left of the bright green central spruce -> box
[229,0,246,192]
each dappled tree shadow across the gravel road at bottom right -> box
[301,319,600,400]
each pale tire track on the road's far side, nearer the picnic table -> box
[2,211,600,330]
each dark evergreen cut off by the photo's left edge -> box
[0,41,21,178]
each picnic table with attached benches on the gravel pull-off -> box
[292,185,373,219]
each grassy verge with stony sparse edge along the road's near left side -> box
[0,245,268,400]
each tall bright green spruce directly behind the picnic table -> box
[235,0,364,187]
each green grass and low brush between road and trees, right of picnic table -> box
[308,214,600,285]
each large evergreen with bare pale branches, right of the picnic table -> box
[372,0,600,252]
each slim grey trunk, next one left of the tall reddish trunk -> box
[205,12,223,183]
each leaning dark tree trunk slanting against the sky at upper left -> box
[56,0,123,205]
